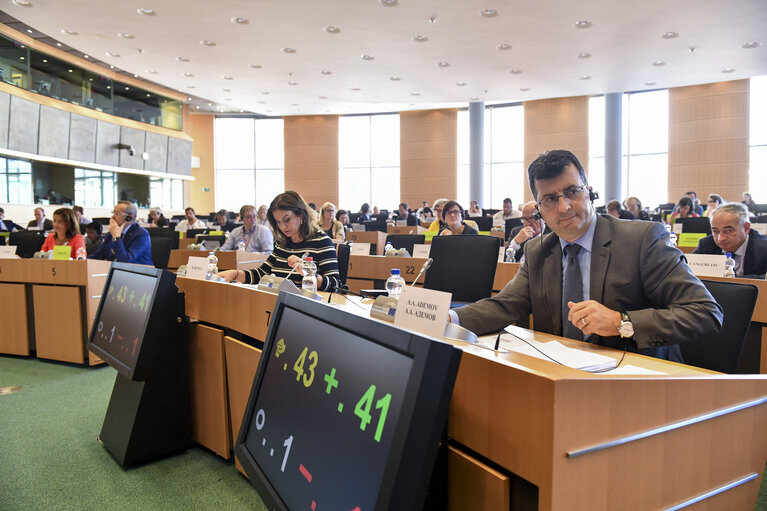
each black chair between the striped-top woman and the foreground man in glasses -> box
[423,234,502,305]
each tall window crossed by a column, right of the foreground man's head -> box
[589,90,668,208]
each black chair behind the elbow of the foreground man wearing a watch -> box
[679,280,759,374]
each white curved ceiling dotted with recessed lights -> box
[5,0,767,116]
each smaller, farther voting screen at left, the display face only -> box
[90,267,158,377]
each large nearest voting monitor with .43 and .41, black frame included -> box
[238,293,460,510]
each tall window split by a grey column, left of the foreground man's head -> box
[457,105,525,209]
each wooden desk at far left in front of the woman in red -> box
[0,259,111,365]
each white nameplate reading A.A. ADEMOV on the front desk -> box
[394,286,453,339]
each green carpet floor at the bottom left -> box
[0,356,767,511]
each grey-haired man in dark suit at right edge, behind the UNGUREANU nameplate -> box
[693,202,767,279]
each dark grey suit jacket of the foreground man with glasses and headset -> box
[456,215,722,361]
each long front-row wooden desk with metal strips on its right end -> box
[172,278,767,510]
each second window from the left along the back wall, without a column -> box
[338,114,400,211]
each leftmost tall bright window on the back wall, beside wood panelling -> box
[214,117,285,211]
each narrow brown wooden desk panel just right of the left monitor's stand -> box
[188,324,232,459]
